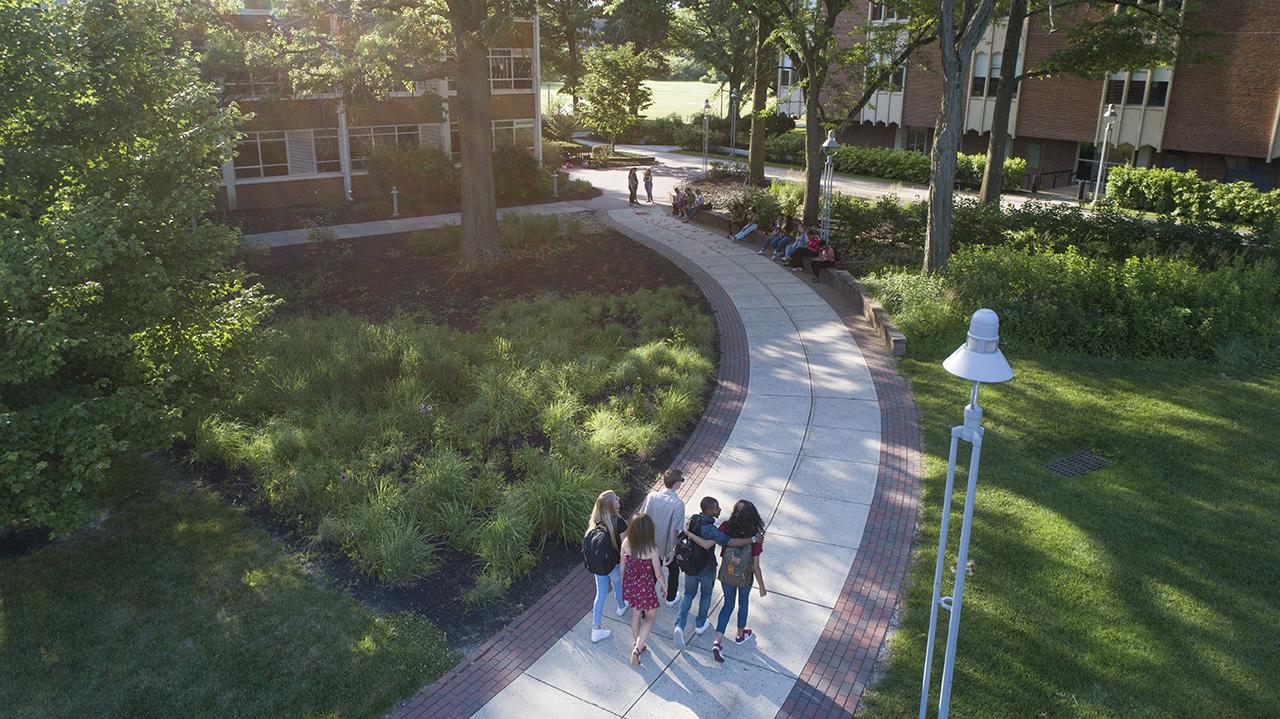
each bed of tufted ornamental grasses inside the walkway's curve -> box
[204,212,714,604]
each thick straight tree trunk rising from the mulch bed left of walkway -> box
[453,32,502,266]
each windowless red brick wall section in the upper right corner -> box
[1164,0,1280,157]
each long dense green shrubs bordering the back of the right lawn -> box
[946,247,1280,358]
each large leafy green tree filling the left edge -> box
[0,0,271,531]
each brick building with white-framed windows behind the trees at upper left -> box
[218,0,541,210]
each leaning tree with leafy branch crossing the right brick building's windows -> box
[980,0,1187,203]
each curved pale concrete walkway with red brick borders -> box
[399,209,919,719]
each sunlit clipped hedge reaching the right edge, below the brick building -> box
[1107,165,1280,242]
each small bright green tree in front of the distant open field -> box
[582,42,653,151]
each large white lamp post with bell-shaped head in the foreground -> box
[919,310,1014,719]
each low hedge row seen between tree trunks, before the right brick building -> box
[764,132,1027,192]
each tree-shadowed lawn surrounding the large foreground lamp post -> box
[867,357,1280,718]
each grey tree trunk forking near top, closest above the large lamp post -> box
[924,0,995,274]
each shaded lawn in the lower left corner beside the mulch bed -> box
[0,459,457,718]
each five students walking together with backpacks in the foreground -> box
[582,470,768,665]
